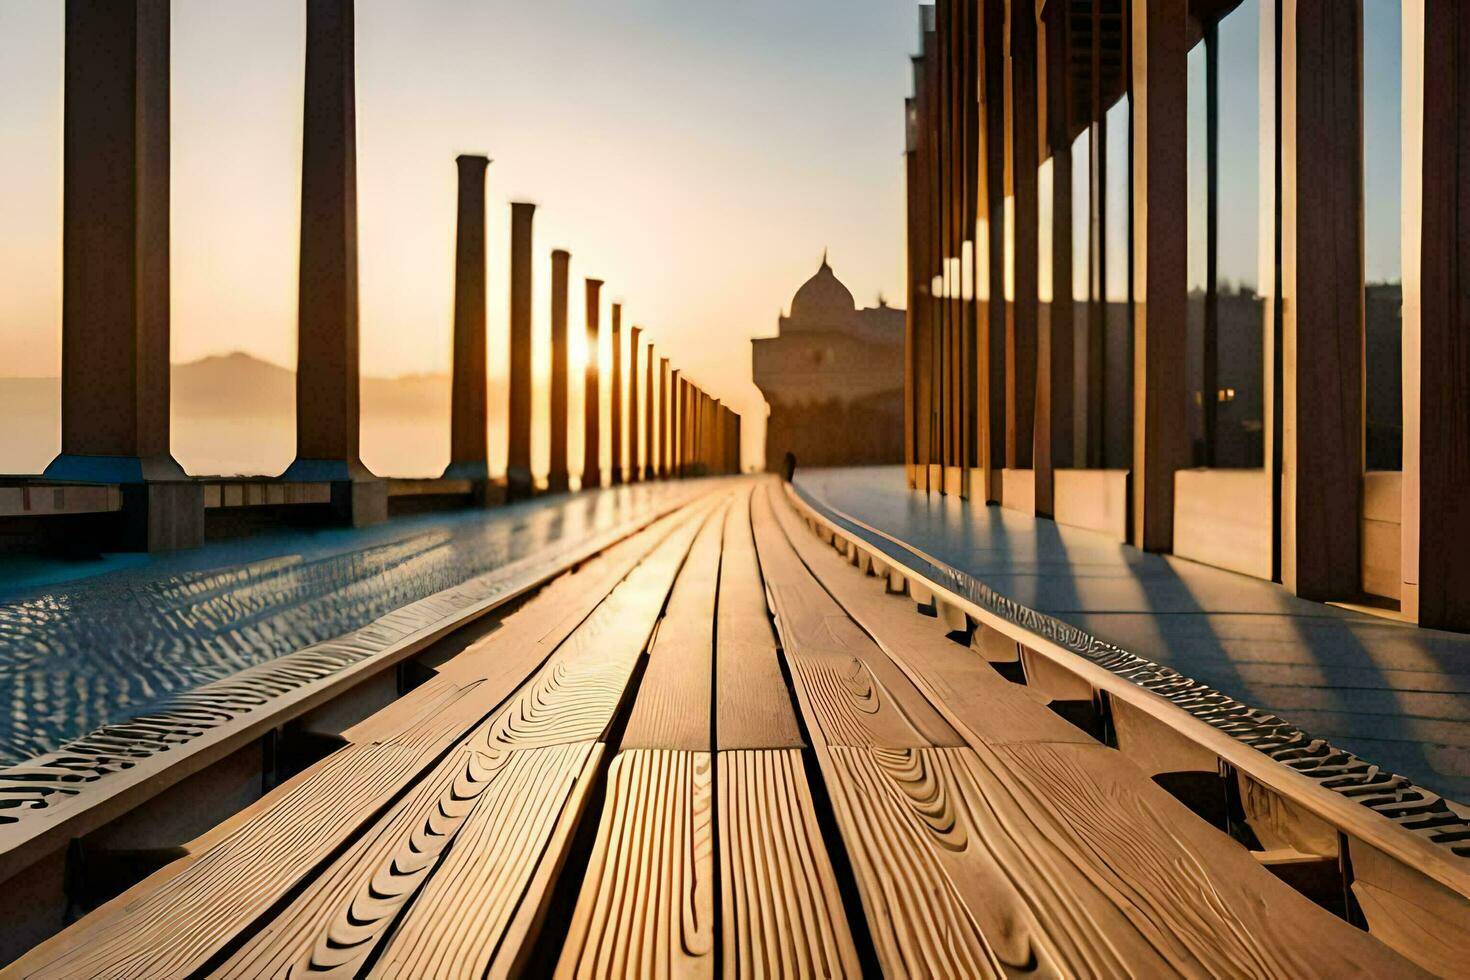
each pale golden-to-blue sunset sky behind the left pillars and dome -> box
[0,0,917,476]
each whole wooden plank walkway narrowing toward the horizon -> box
[6,480,1419,979]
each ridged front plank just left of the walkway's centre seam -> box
[556,749,716,977]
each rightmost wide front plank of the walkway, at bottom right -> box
[967,743,1420,977]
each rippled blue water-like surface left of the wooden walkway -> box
[0,483,682,767]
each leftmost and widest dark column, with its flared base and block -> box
[46,0,204,551]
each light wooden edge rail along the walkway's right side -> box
[785,483,1470,898]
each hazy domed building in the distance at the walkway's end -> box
[751,256,904,473]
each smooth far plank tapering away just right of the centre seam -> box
[714,482,806,749]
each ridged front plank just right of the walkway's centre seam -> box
[717,749,861,977]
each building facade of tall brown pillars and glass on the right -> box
[904,0,1470,630]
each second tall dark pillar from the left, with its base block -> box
[282,0,388,526]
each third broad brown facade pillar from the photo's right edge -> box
[1130,0,1189,551]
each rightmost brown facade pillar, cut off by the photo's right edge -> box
[1404,0,1470,630]
